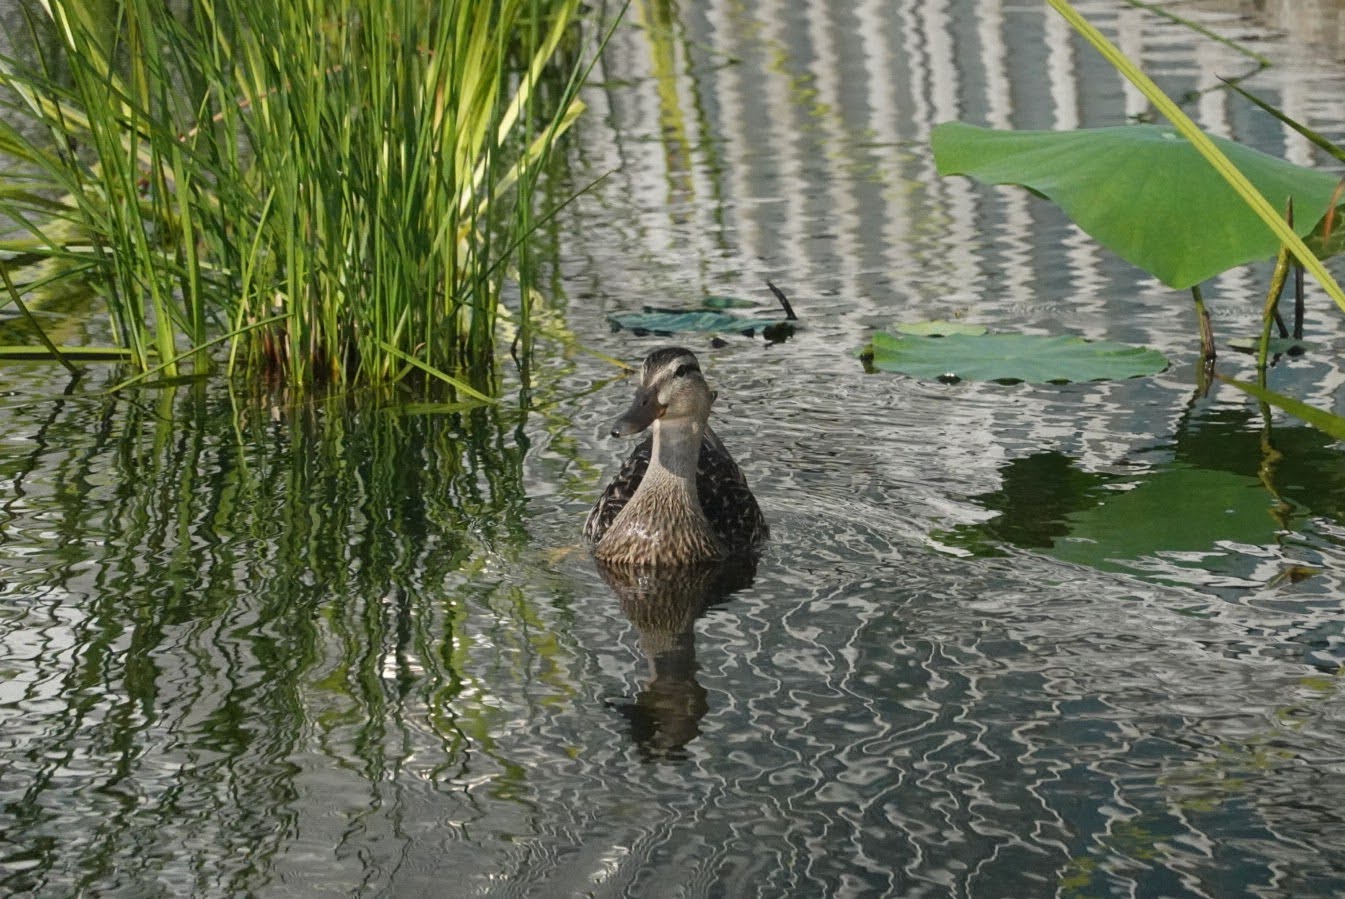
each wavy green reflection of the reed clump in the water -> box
[0,376,589,892]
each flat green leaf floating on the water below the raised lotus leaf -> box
[865,331,1167,384]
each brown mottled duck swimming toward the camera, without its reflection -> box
[584,347,769,567]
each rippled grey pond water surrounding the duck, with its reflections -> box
[0,0,1345,898]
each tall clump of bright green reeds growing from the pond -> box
[0,0,582,384]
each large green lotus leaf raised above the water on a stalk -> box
[932,122,1337,288]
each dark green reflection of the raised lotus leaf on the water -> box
[939,395,1345,585]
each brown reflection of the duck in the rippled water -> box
[594,559,756,760]
